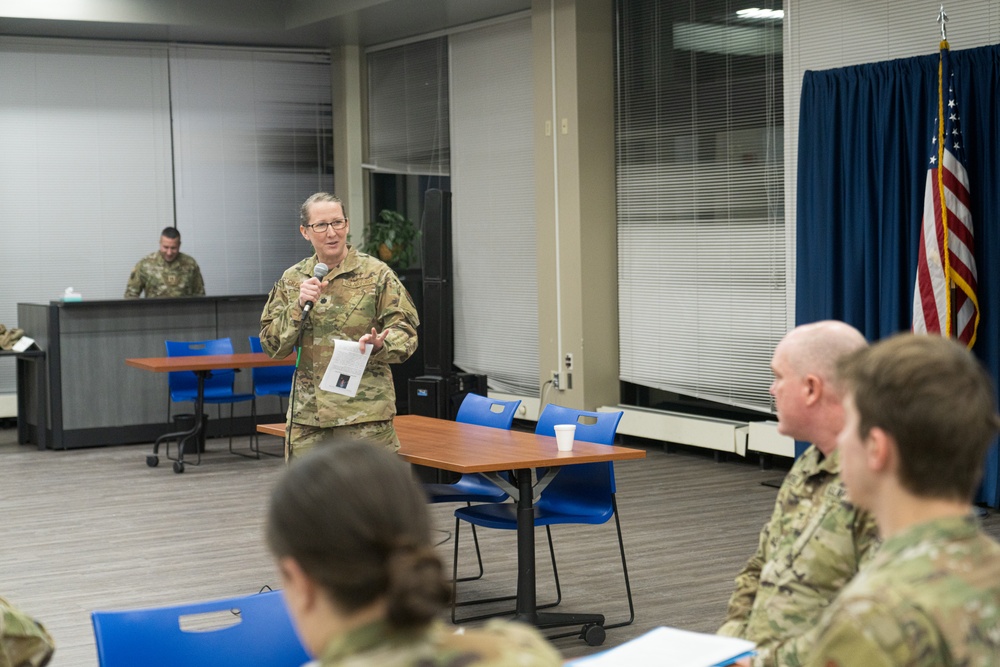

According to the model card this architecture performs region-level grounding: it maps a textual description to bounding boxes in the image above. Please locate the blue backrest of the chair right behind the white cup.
[535,403,623,521]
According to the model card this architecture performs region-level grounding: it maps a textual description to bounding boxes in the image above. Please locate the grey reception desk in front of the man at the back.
[17,294,284,449]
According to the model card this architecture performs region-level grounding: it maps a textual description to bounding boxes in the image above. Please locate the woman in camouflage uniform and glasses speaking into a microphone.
[260,192,419,459]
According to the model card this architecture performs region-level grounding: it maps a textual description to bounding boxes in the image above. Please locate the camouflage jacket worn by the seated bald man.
[718,446,879,667]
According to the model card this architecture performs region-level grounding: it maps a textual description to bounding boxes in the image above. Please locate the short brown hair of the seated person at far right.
[838,334,1000,501]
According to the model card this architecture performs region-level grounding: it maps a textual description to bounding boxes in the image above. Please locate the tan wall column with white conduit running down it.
[532,0,619,410]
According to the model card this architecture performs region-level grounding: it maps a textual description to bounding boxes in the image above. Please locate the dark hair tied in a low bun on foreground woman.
[267,442,450,628]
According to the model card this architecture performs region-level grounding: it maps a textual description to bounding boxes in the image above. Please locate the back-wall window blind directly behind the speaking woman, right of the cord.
[170,46,333,294]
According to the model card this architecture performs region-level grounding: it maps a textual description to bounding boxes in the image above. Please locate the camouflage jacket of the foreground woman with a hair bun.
[318,620,562,667]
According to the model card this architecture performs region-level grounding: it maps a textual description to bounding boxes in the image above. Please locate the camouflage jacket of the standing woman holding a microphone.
[260,248,420,428]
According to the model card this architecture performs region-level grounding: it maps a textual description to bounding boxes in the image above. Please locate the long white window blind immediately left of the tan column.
[449,18,538,396]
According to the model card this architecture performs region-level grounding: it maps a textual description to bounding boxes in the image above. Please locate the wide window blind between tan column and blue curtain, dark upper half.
[616,0,789,411]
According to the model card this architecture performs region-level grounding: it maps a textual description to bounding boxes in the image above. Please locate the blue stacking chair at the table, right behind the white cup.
[453,403,635,634]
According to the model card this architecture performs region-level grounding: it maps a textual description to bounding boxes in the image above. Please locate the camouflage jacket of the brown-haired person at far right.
[808,516,1000,667]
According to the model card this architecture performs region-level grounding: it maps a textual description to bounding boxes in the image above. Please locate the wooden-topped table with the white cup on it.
[257,415,646,640]
